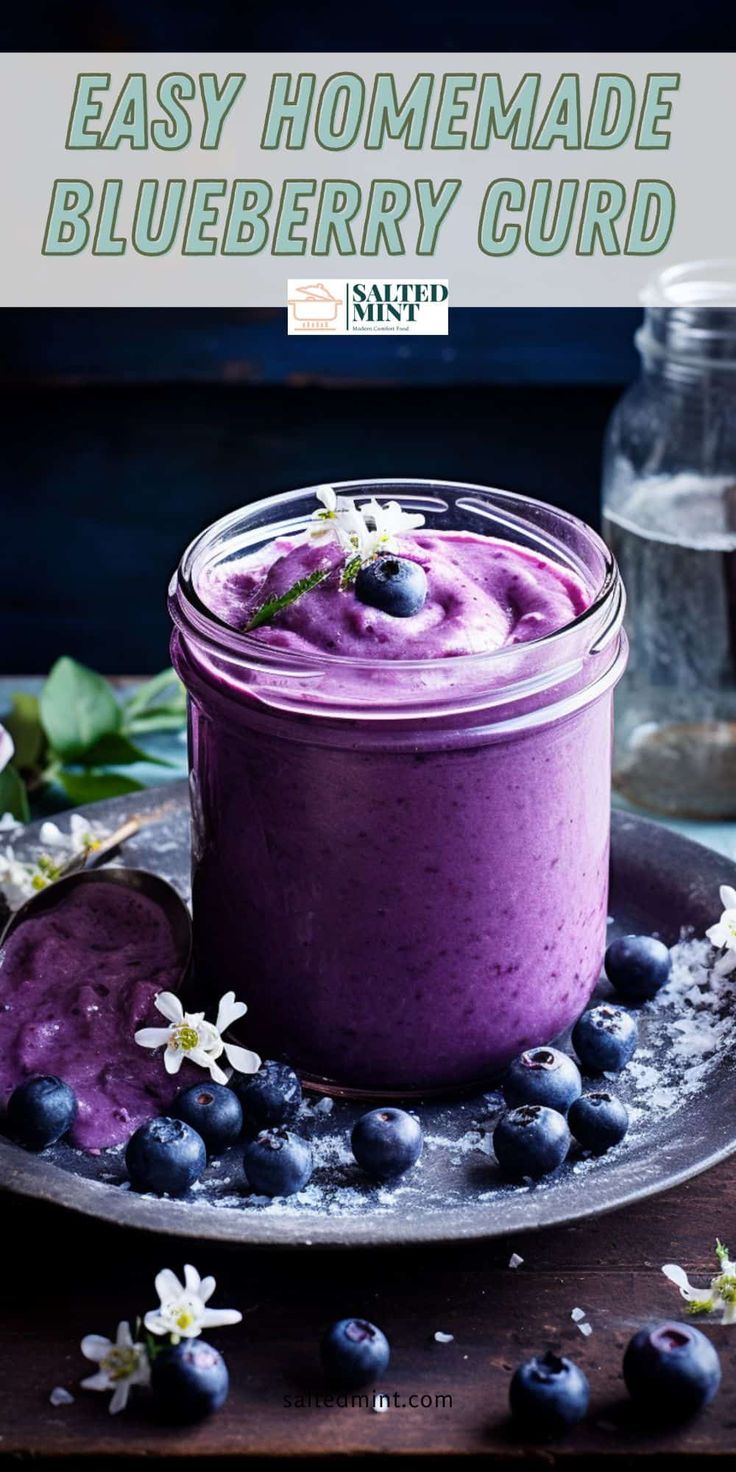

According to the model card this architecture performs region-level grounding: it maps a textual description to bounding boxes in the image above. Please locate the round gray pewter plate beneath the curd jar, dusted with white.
[0,783,736,1247]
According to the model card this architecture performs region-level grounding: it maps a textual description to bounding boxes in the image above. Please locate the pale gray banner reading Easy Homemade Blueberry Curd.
[0,53,736,310]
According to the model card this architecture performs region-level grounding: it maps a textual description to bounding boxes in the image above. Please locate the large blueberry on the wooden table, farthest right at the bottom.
[624,1323,721,1422]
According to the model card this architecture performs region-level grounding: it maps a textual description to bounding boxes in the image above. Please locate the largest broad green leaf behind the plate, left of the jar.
[41,655,121,761]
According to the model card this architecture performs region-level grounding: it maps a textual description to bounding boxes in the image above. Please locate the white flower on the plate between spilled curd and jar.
[135,992,261,1083]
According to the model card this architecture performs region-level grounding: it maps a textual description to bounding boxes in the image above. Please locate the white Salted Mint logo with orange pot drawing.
[287,278,449,337]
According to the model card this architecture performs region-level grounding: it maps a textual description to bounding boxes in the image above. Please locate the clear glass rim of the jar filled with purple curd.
[169,477,623,677]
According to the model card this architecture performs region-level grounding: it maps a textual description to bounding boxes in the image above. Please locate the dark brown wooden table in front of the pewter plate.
[0,1161,736,1465]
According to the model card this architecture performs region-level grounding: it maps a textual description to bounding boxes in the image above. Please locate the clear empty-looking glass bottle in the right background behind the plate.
[604,262,736,818]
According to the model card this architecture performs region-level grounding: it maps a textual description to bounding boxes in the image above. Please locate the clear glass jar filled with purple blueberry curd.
[169,481,626,1097]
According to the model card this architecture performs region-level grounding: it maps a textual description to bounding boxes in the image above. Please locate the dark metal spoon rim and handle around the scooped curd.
[0,818,191,988]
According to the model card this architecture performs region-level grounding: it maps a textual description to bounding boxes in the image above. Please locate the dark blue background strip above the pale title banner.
[3,0,735,52]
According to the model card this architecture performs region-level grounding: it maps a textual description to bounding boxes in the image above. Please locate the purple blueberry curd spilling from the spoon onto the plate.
[0,883,192,1150]
